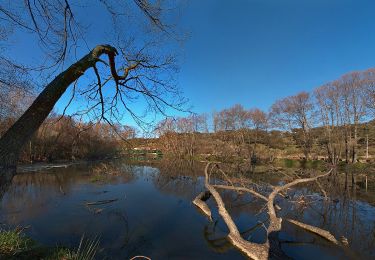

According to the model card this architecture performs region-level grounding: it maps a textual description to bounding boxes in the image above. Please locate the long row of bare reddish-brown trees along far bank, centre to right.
[157,69,375,164]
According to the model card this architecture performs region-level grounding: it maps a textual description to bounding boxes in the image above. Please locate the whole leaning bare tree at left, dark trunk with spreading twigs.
[0,0,185,185]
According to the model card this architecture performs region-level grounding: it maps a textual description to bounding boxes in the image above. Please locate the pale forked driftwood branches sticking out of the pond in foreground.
[193,163,346,259]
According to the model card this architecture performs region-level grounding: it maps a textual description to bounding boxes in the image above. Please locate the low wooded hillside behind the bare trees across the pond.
[130,120,375,162]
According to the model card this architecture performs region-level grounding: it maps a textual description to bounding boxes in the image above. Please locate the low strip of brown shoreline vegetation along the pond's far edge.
[18,154,375,179]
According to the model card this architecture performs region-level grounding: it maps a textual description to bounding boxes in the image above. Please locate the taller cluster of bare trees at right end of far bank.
[270,69,375,164]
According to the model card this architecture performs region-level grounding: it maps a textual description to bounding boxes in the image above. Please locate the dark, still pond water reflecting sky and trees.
[0,159,375,259]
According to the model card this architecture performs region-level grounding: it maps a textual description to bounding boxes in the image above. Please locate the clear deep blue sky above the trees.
[9,0,375,127]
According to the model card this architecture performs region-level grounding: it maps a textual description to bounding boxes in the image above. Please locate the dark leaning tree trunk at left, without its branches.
[0,45,117,185]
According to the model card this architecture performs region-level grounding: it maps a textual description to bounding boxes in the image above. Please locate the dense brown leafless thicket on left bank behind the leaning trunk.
[0,111,136,163]
